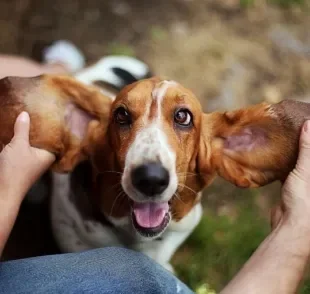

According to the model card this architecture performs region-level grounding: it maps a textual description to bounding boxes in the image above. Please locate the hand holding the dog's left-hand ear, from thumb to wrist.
[0,112,55,200]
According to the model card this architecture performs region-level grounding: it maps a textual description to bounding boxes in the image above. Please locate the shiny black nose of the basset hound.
[131,162,169,197]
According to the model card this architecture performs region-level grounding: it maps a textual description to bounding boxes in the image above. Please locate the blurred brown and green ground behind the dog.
[0,0,310,293]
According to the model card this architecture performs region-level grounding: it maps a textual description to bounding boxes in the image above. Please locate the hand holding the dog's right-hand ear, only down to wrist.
[271,121,310,228]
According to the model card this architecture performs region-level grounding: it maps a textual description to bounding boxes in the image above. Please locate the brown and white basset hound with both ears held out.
[0,76,310,271]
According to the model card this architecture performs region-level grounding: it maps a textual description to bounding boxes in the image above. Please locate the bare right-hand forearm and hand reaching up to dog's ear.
[221,121,310,294]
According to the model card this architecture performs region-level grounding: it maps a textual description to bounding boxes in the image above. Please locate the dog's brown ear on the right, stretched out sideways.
[199,100,310,187]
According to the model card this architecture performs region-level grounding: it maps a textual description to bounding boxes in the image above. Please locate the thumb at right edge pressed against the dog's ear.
[295,120,310,180]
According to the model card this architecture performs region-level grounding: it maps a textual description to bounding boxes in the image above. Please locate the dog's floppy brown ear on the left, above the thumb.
[0,75,111,172]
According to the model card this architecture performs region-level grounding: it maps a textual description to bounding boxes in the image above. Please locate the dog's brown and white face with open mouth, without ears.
[104,78,202,236]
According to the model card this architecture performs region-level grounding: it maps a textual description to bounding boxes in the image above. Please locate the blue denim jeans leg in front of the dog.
[0,247,193,294]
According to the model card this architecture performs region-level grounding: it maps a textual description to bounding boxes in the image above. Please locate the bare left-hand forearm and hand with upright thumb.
[0,112,55,255]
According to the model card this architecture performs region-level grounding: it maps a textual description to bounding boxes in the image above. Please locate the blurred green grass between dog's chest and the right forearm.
[173,195,310,294]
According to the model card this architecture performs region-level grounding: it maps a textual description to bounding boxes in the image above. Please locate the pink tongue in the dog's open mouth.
[133,202,169,228]
